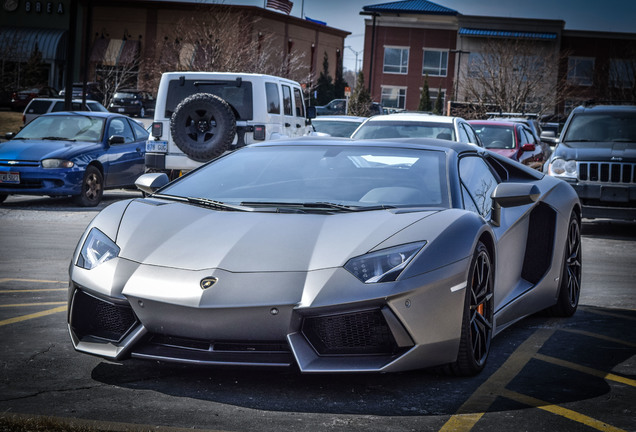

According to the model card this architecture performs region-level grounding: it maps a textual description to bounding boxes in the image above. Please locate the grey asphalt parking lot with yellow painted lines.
[0,191,636,431]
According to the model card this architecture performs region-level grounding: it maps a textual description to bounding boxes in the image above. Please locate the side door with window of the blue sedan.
[104,117,148,187]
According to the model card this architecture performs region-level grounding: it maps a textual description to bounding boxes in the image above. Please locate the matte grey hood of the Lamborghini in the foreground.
[116,199,435,272]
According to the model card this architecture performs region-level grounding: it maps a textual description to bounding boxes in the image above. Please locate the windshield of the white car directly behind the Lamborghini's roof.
[352,121,455,141]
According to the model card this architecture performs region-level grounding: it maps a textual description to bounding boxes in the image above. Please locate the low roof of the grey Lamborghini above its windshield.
[248,136,476,153]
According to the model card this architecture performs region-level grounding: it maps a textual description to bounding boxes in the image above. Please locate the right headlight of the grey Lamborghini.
[344,241,426,283]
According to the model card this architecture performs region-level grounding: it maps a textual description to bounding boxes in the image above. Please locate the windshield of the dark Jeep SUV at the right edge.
[562,112,636,147]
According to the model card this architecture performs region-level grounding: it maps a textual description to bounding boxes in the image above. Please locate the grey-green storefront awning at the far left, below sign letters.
[0,27,67,63]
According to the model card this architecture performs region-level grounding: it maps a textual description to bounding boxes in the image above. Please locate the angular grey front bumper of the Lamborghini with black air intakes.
[68,258,467,372]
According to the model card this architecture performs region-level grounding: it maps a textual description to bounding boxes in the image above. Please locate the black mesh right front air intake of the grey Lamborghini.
[302,310,397,354]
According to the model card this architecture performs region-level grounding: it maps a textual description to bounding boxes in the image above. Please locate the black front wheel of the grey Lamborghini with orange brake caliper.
[449,242,494,376]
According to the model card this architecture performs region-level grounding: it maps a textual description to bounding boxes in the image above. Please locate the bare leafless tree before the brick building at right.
[459,38,567,114]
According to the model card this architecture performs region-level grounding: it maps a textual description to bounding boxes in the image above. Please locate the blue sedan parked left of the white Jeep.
[0,112,148,207]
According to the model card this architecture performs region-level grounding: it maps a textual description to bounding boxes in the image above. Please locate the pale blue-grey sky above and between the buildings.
[223,0,636,70]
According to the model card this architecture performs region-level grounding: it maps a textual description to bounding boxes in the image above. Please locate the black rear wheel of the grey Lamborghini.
[548,213,582,317]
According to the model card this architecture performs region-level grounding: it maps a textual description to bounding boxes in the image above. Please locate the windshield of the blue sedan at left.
[13,114,104,142]
